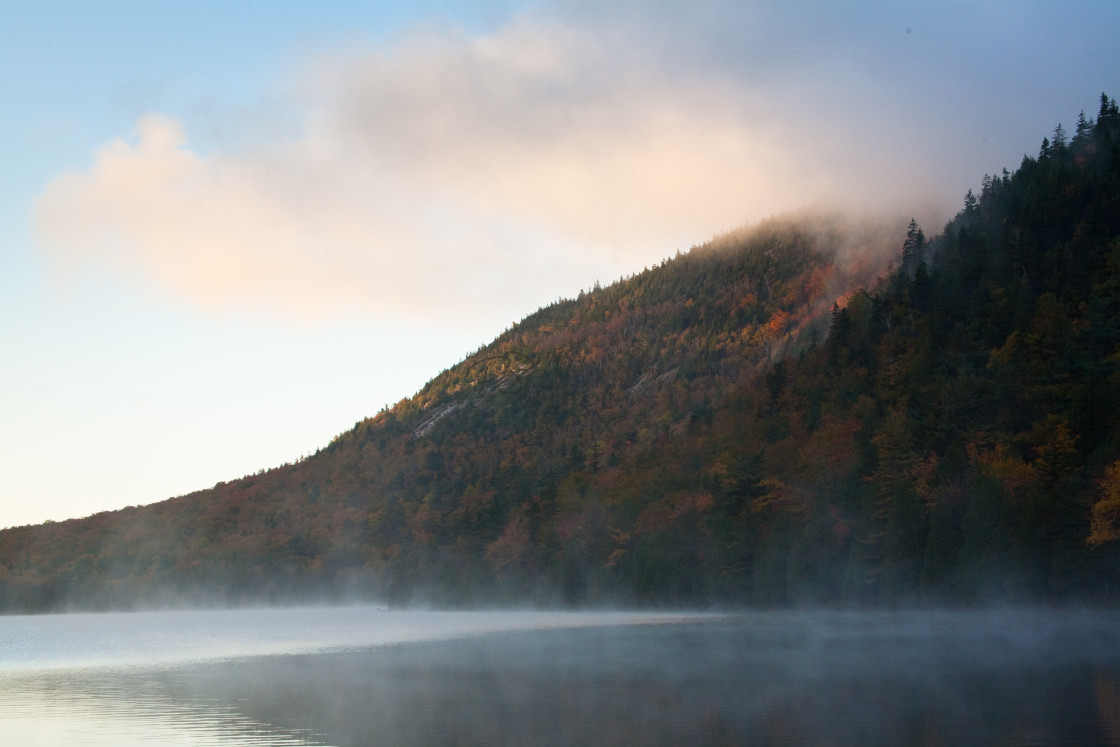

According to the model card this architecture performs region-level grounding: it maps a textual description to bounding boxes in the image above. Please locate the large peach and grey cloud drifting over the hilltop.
[35,3,1111,320]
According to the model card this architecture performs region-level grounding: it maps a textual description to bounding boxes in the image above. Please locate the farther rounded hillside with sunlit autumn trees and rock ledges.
[0,212,887,609]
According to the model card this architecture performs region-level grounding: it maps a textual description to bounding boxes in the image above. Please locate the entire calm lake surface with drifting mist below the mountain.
[0,607,1120,746]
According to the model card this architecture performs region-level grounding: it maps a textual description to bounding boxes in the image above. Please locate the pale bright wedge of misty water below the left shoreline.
[0,606,710,672]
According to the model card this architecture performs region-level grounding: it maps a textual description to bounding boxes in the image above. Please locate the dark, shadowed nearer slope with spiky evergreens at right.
[712,95,1120,603]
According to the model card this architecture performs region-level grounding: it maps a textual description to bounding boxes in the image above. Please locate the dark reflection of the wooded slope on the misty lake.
[8,614,1120,746]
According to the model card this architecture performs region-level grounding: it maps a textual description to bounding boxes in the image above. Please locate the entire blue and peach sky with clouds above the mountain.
[0,0,1120,526]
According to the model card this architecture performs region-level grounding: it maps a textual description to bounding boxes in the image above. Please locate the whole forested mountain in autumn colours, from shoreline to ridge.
[0,95,1120,611]
